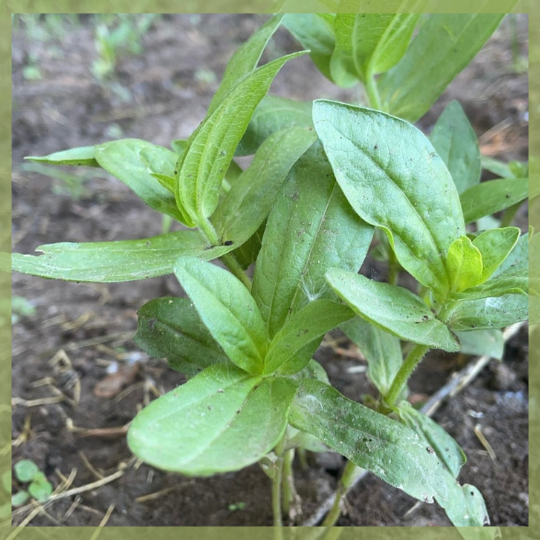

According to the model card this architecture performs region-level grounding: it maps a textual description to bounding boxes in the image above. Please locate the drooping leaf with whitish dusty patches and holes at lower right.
[289,380,487,526]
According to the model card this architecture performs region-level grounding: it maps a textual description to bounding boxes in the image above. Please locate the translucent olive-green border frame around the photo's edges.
[0,0,540,540]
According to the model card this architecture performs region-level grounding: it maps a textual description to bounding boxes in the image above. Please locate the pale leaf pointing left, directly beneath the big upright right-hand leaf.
[326,268,459,352]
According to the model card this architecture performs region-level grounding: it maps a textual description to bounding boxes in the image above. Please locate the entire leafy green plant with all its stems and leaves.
[13,14,528,526]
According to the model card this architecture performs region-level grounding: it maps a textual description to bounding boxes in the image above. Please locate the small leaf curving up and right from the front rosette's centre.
[263,299,354,375]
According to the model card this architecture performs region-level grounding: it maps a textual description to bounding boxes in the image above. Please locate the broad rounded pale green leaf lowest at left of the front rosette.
[128,364,296,476]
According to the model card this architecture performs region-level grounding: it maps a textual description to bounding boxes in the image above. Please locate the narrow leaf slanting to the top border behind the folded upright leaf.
[207,15,283,115]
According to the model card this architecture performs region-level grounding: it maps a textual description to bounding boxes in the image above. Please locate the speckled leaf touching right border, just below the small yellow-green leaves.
[444,294,529,332]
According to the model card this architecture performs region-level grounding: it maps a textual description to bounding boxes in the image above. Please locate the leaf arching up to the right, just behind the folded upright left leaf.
[212,128,317,246]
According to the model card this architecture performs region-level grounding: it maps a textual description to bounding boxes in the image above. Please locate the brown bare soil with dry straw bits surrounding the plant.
[13,15,528,526]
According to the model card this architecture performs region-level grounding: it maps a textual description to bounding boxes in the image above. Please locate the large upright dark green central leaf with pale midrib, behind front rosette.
[252,143,373,338]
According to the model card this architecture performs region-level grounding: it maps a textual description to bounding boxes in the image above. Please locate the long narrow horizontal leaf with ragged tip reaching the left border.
[12,231,234,283]
